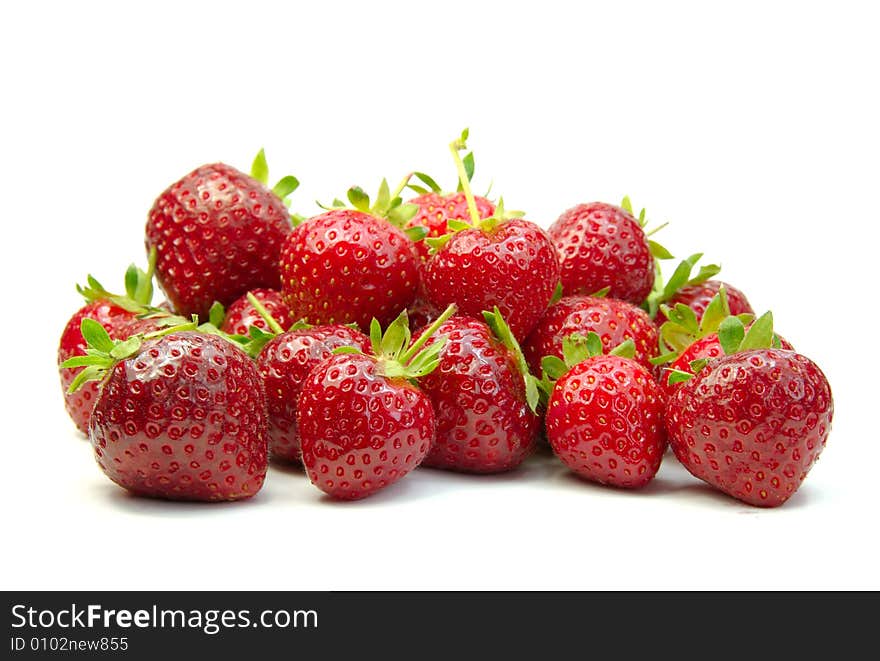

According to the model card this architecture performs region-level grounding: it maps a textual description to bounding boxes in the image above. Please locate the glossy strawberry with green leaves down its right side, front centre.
[416,309,539,473]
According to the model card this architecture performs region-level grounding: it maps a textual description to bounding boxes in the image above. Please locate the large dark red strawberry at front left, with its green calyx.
[66,319,267,500]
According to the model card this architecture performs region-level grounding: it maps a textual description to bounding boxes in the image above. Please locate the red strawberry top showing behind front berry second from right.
[523,295,658,374]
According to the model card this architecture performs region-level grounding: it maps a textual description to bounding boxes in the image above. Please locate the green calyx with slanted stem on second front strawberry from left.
[333,305,456,385]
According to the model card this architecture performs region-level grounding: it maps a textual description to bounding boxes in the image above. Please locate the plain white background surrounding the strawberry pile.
[0,0,880,589]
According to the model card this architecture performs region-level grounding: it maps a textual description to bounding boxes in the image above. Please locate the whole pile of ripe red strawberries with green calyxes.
[58,131,833,507]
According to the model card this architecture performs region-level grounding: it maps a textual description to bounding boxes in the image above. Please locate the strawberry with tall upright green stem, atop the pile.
[424,130,559,341]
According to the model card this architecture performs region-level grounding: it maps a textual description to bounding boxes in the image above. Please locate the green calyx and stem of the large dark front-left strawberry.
[60,316,198,393]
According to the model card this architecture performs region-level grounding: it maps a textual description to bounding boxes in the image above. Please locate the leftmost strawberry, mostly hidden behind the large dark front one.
[58,255,165,434]
